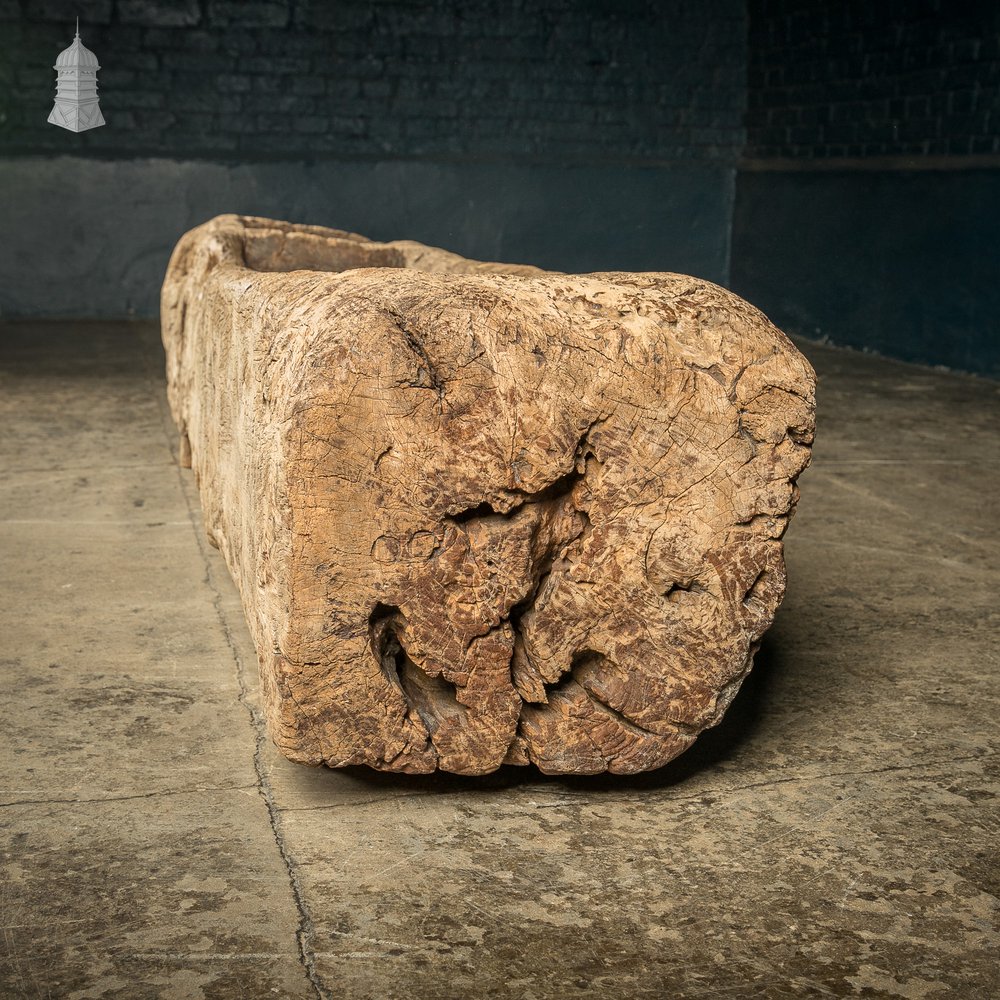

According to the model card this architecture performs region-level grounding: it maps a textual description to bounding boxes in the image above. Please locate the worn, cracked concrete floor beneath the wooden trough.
[0,323,1000,1000]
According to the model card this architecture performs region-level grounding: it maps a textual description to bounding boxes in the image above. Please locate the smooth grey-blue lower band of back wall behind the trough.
[0,157,735,316]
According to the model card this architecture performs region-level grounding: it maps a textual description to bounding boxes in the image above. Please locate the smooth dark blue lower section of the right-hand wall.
[732,170,1000,377]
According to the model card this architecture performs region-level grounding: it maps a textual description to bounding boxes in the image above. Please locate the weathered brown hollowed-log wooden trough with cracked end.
[162,216,814,774]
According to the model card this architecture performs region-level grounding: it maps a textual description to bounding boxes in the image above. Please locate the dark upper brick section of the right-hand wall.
[747,0,1000,159]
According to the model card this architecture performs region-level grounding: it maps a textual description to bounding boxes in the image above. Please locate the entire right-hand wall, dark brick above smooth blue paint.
[731,0,1000,376]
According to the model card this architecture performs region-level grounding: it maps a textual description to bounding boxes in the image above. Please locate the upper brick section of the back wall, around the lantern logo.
[0,0,746,163]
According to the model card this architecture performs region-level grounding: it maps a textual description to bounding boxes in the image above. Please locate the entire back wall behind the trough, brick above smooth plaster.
[0,0,746,316]
